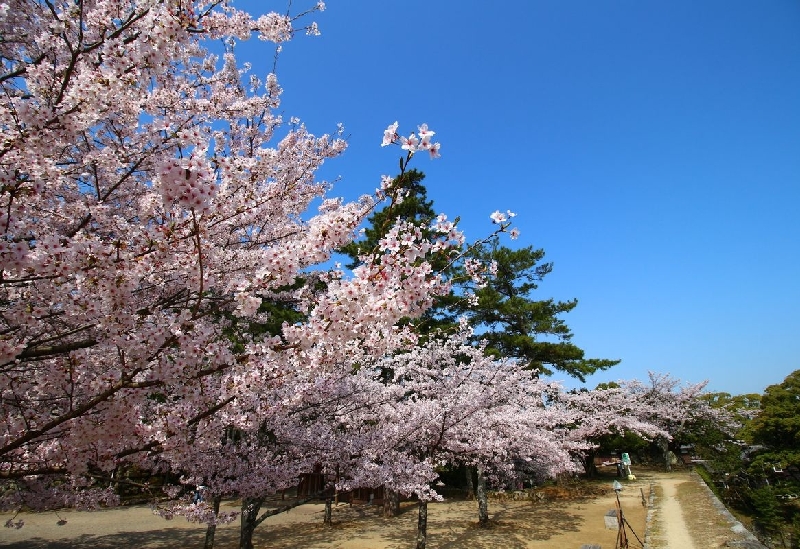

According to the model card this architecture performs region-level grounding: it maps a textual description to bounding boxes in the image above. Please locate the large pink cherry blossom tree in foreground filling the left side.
[0,0,460,520]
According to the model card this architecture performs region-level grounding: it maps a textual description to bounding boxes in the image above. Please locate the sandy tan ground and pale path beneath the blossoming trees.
[0,466,764,549]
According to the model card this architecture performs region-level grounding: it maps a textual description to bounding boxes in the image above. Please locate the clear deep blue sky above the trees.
[235,0,800,394]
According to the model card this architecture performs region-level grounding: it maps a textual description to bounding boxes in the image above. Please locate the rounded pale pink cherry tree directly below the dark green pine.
[318,331,575,548]
